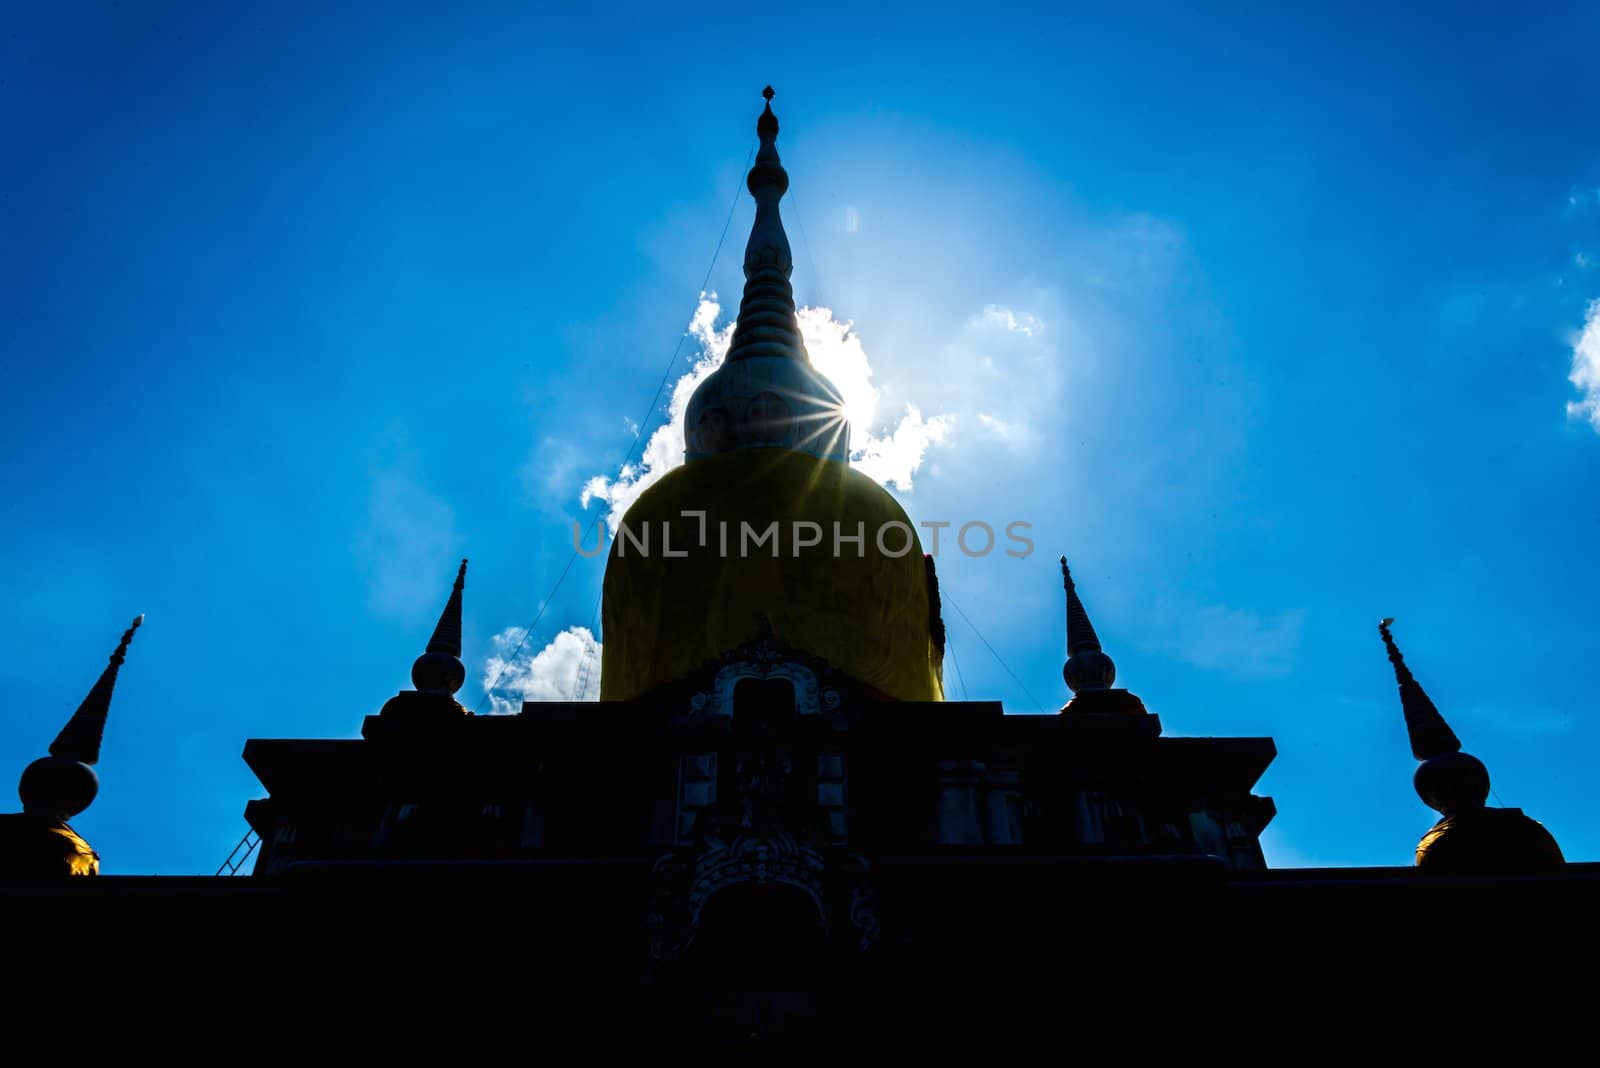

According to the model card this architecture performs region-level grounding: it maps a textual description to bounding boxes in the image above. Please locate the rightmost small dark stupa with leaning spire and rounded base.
[1378,617,1563,875]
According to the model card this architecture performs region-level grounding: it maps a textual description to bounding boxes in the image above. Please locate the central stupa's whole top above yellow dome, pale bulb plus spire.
[683,86,850,464]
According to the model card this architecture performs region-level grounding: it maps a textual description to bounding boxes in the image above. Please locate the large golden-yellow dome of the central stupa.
[600,448,944,700]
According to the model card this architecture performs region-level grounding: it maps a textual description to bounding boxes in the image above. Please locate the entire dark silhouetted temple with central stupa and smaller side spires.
[0,91,1600,1054]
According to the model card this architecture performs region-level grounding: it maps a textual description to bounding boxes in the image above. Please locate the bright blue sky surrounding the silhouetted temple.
[0,5,1600,873]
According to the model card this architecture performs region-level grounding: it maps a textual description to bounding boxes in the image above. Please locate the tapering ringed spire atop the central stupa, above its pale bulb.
[728,86,811,363]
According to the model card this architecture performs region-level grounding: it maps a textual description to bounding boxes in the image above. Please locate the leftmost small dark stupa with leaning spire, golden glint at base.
[0,616,144,879]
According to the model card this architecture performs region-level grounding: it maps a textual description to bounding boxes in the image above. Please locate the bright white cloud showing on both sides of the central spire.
[579,293,947,531]
